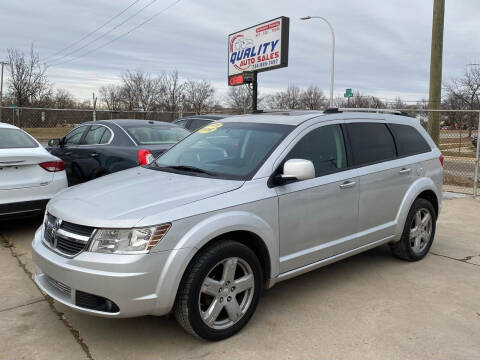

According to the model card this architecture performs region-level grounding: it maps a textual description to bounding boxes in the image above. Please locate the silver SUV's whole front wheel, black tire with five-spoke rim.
[174,239,263,341]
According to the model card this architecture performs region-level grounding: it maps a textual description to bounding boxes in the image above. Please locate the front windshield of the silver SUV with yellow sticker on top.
[155,122,294,180]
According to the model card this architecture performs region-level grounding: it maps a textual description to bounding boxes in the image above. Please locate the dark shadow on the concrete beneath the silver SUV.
[51,246,403,358]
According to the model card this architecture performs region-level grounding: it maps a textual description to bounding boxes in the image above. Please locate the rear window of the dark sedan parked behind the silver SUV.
[124,125,190,145]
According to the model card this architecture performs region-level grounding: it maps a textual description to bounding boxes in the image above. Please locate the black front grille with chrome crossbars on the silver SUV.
[44,214,94,256]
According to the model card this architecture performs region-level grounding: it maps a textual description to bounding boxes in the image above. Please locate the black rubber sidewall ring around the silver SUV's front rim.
[187,241,263,341]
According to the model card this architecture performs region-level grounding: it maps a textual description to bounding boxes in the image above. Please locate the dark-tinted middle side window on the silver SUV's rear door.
[346,123,396,166]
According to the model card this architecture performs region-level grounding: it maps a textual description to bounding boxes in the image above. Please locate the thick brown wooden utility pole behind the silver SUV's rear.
[428,0,445,145]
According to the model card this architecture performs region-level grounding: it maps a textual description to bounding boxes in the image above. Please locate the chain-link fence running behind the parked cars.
[0,107,480,194]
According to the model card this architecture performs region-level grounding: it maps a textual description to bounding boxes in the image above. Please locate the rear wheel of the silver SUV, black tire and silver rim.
[390,198,437,261]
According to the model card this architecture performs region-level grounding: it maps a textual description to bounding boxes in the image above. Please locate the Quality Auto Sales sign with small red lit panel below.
[228,16,289,86]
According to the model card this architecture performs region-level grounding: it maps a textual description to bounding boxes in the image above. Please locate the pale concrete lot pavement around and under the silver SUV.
[0,198,480,360]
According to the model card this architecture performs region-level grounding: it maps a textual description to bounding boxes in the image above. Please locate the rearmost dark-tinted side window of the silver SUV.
[390,124,432,156]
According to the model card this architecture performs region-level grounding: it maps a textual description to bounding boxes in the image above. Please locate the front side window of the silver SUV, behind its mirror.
[284,125,347,177]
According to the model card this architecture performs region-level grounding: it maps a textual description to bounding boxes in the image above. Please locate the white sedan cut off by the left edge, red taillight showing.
[0,123,68,219]
